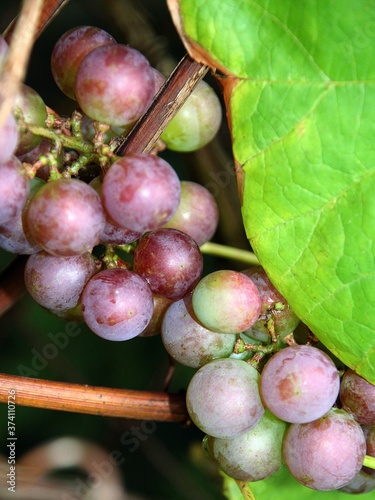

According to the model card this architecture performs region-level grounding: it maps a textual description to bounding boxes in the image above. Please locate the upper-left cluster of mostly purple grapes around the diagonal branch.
[0,26,221,341]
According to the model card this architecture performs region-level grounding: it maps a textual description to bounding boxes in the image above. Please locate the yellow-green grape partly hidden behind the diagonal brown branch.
[161,82,222,153]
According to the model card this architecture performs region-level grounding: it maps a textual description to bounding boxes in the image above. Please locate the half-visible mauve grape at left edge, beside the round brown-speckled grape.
[0,156,29,225]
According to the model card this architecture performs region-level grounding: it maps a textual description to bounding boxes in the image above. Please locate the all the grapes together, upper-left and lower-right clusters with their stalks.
[0,26,375,492]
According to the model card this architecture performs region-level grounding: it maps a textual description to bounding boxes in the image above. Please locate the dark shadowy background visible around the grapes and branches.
[0,0,253,500]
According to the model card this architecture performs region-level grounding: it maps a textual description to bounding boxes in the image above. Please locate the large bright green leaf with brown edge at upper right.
[168,0,375,383]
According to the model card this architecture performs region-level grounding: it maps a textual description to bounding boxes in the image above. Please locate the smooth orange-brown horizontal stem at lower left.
[0,374,189,424]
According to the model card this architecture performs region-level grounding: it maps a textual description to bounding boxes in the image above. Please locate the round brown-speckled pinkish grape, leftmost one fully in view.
[27,179,105,256]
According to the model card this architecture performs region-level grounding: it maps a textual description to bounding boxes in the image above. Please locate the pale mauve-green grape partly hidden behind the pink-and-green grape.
[161,295,236,368]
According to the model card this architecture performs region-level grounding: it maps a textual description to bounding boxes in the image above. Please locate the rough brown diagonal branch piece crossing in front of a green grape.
[115,54,208,156]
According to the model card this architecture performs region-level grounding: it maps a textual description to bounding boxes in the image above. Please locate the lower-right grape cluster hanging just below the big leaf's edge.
[161,266,375,493]
